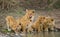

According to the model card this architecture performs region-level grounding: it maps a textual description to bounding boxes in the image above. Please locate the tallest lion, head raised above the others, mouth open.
[17,9,35,33]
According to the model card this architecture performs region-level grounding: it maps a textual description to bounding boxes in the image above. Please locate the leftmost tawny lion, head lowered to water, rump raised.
[6,16,21,34]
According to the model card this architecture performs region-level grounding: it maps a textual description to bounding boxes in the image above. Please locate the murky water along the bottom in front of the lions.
[0,32,60,37]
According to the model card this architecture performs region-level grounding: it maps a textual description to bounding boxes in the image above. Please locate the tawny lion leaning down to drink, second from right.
[28,16,45,32]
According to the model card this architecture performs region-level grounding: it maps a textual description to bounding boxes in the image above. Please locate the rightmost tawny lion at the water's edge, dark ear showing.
[43,17,55,31]
